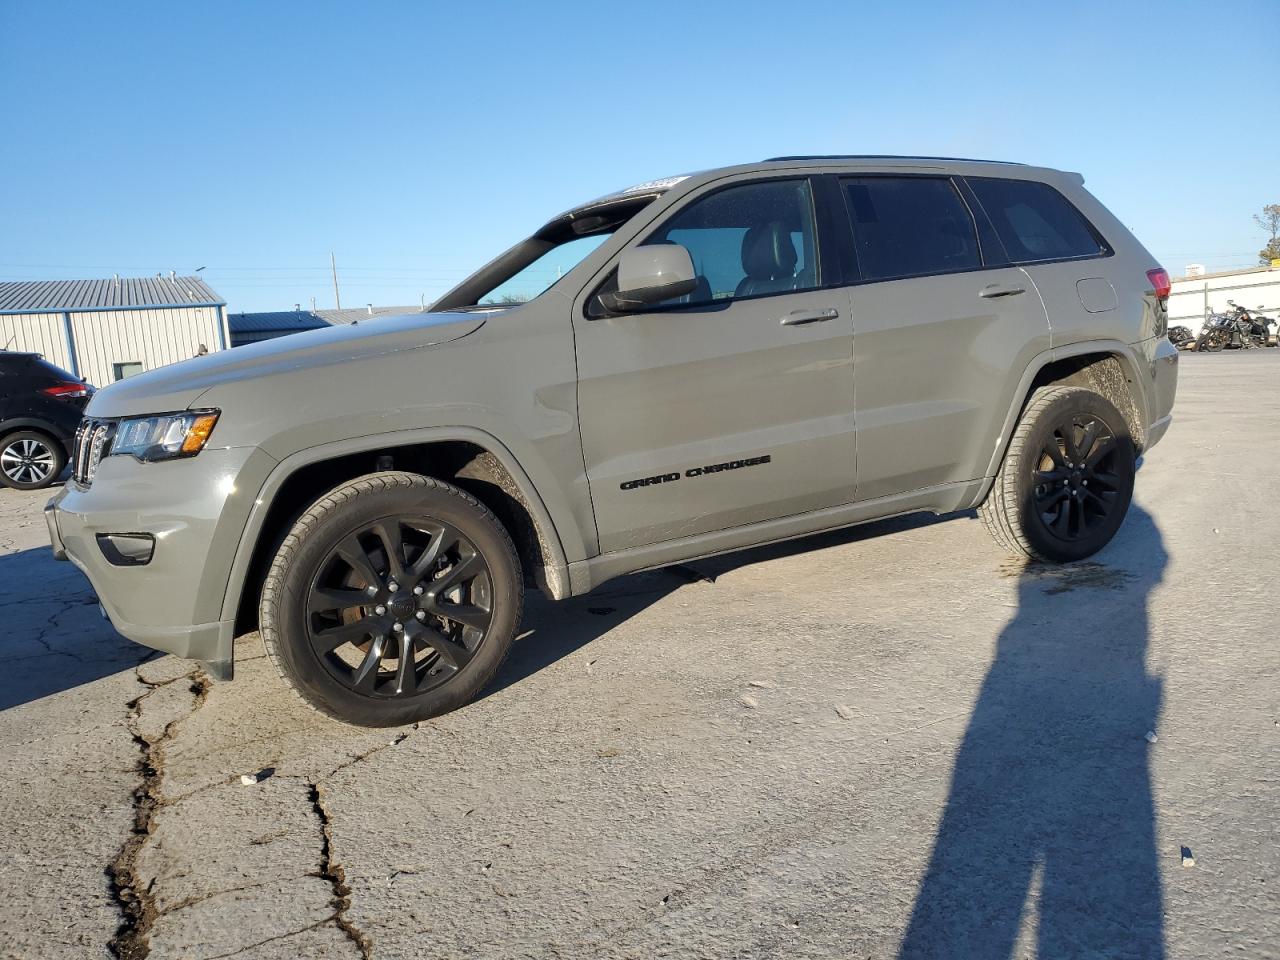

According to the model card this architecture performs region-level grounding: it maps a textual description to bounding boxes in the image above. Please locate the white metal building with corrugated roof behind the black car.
[0,274,230,387]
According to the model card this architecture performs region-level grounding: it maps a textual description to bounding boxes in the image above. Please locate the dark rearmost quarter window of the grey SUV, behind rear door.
[968,177,1107,264]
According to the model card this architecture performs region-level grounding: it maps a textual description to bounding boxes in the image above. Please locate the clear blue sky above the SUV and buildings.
[0,0,1280,311]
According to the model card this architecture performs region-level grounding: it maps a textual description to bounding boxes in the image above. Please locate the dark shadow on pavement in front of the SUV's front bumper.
[0,547,148,710]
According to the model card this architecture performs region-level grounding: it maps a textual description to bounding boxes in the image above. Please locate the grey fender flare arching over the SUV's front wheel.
[221,426,570,621]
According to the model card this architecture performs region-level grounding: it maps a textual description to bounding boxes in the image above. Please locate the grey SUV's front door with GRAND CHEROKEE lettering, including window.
[575,177,854,553]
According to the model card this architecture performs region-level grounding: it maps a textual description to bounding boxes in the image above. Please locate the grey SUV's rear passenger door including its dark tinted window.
[841,174,1050,500]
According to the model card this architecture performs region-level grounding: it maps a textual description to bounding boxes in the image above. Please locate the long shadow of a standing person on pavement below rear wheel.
[900,504,1167,960]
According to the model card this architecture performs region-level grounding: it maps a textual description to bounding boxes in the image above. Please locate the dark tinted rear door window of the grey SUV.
[841,177,982,280]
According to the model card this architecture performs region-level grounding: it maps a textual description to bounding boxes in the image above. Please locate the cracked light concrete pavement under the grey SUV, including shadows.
[0,351,1280,959]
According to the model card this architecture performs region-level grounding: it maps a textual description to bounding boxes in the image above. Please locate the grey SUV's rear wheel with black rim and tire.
[978,387,1135,563]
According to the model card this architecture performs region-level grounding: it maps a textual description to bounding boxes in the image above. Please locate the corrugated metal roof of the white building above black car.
[0,276,225,314]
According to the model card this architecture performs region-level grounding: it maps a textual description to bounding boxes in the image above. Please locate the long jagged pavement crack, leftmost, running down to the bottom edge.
[106,664,210,960]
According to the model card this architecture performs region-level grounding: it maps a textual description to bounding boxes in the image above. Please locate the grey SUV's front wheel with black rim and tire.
[260,472,525,727]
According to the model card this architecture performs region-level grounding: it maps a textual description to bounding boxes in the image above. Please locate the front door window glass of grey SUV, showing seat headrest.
[645,179,822,306]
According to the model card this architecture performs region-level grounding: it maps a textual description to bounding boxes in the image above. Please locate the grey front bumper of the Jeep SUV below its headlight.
[45,448,275,672]
